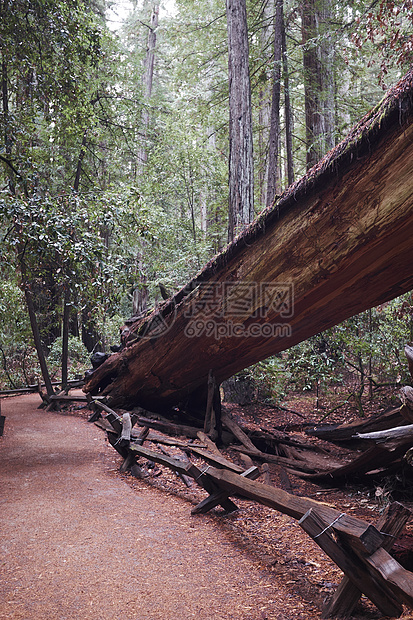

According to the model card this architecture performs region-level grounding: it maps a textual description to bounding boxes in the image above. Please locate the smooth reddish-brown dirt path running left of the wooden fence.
[0,395,304,620]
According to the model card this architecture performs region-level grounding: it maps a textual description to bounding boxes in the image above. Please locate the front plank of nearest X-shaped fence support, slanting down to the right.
[299,508,403,618]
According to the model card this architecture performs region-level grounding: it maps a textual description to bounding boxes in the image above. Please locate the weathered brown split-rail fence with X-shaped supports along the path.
[88,397,413,618]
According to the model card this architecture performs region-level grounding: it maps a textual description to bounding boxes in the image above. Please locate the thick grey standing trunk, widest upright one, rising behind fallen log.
[226,0,254,241]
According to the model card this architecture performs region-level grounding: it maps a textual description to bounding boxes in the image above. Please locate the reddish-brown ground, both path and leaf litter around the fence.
[0,395,413,620]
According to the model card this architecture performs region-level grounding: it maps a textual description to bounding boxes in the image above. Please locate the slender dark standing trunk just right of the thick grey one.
[266,0,283,206]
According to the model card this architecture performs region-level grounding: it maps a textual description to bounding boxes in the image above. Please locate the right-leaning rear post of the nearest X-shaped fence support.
[322,502,411,618]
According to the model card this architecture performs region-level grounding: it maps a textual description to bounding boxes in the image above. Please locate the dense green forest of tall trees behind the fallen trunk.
[0,0,413,413]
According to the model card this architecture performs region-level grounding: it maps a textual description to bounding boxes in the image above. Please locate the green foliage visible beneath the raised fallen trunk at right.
[245,293,413,410]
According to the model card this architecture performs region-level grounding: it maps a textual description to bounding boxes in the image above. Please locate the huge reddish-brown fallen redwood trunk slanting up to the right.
[85,71,413,411]
